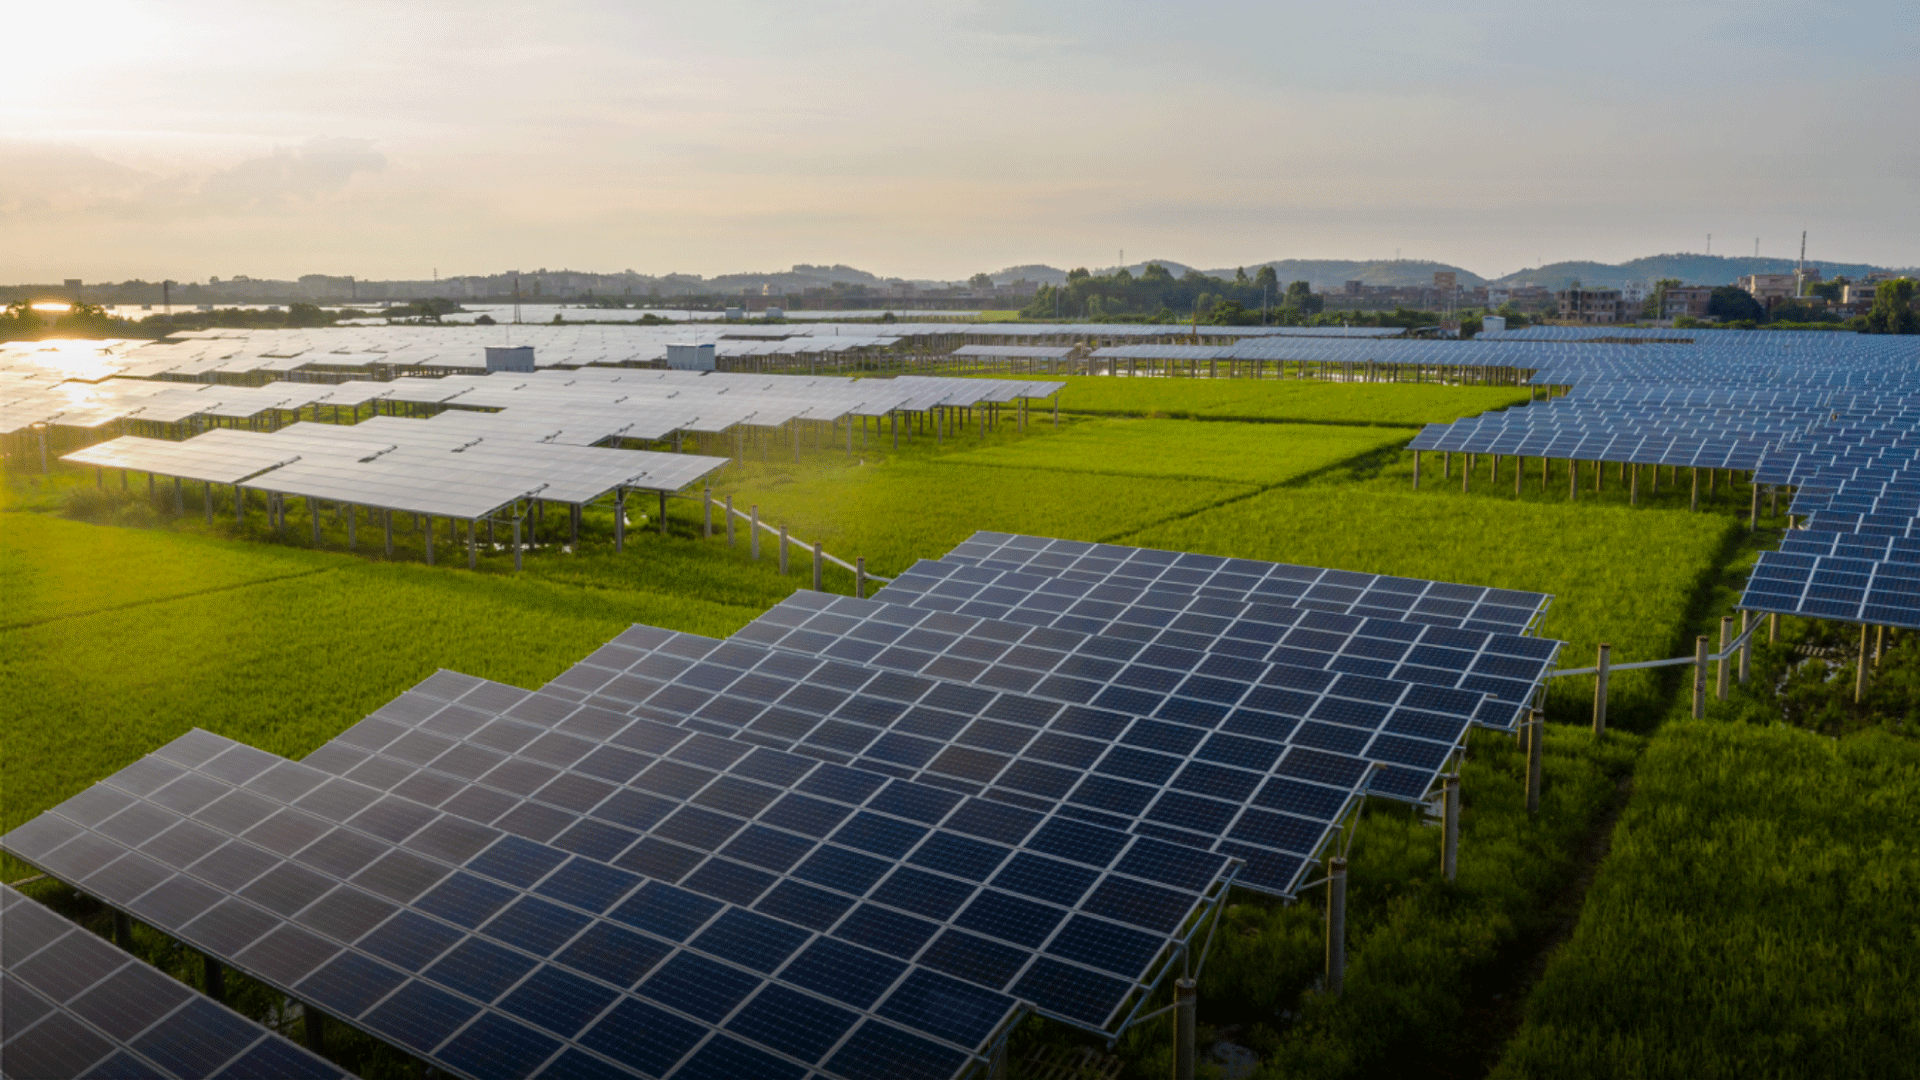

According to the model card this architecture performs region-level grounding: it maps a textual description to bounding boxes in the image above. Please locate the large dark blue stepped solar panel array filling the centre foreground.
[0,534,1559,1080]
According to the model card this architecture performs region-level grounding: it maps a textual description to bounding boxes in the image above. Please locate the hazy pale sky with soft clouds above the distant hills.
[0,0,1920,282]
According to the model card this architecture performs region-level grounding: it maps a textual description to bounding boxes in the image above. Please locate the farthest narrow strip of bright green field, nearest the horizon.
[1046,375,1526,427]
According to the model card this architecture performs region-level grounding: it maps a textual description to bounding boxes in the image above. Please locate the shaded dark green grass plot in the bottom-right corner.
[1494,719,1920,1080]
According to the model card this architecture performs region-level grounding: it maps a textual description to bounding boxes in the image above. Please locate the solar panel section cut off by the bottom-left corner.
[0,886,346,1080]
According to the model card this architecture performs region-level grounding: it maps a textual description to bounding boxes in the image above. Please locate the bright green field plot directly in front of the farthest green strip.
[937,419,1415,486]
